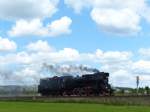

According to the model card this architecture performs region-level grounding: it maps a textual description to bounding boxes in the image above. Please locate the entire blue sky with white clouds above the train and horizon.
[0,0,150,87]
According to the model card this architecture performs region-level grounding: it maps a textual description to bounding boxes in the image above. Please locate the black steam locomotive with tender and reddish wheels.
[38,72,112,96]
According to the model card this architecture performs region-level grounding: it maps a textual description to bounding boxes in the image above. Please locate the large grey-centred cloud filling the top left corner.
[0,0,59,20]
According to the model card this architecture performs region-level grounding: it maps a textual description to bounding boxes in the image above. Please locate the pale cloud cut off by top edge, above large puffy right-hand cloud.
[65,0,147,12]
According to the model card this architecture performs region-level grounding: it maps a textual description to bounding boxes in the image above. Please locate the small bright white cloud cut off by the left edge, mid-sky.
[0,37,17,52]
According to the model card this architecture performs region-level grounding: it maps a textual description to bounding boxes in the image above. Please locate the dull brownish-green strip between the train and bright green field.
[0,95,150,106]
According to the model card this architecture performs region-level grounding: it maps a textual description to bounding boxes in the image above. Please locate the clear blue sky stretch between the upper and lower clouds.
[7,1,150,52]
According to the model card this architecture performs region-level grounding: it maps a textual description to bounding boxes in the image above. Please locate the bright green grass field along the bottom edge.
[0,102,150,112]
